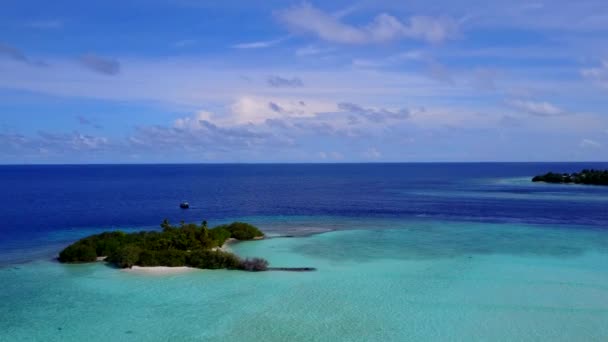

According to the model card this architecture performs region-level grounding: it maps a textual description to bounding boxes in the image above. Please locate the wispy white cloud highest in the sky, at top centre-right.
[277,3,458,44]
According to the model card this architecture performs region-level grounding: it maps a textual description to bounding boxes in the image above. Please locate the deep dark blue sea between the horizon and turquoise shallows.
[0,163,608,264]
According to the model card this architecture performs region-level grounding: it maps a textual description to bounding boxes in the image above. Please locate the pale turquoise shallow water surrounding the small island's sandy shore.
[0,217,608,341]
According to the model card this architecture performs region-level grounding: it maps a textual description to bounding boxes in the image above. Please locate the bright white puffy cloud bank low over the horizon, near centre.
[166,96,410,146]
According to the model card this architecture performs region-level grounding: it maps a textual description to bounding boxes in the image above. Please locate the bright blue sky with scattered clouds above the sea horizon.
[0,0,608,164]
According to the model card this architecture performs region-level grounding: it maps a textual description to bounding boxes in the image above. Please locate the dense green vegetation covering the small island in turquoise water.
[59,219,268,271]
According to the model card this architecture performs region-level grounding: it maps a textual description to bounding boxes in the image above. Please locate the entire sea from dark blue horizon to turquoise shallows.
[0,163,608,341]
